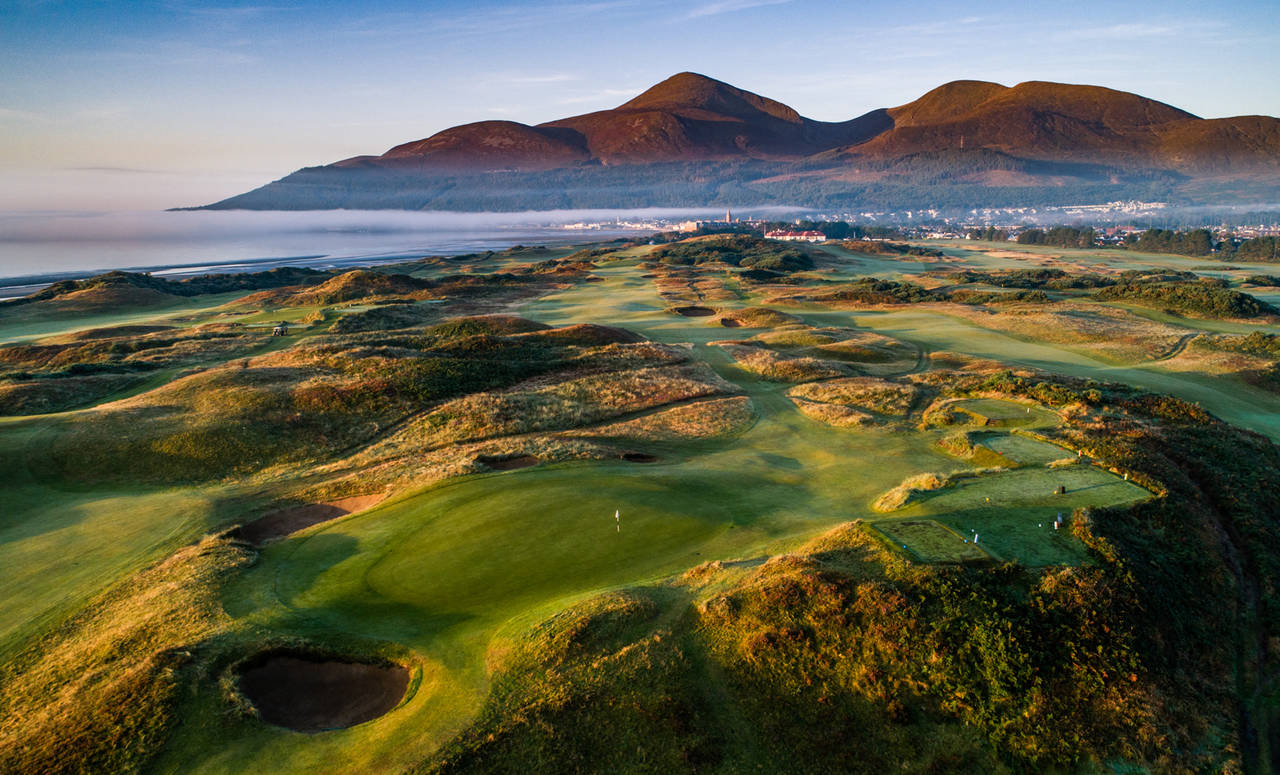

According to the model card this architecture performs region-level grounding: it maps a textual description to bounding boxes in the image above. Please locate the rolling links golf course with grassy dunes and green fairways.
[0,234,1280,774]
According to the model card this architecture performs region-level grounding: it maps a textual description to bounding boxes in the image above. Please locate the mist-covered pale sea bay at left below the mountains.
[0,209,773,286]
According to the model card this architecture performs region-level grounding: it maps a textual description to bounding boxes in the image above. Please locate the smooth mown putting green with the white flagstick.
[275,466,762,635]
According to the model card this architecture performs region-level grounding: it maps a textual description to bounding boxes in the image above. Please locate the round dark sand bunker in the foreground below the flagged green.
[239,655,408,731]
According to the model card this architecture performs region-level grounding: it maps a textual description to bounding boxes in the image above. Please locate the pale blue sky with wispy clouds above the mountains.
[0,0,1280,210]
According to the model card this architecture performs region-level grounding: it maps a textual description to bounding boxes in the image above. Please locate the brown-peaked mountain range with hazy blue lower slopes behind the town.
[197,73,1280,210]
